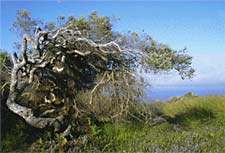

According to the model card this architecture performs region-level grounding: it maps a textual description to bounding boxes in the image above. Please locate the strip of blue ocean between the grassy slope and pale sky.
[144,83,225,102]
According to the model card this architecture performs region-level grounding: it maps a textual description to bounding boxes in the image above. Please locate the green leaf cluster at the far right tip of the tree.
[142,41,195,79]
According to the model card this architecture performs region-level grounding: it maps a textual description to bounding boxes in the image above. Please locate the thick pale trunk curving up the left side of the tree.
[7,28,63,128]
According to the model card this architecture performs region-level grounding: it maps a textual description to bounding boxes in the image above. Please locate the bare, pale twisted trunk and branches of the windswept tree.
[7,24,132,133]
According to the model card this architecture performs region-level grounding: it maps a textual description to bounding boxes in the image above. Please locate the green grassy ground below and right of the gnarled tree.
[1,94,225,152]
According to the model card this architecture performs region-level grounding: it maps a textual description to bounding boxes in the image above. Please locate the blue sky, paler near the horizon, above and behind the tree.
[0,0,225,85]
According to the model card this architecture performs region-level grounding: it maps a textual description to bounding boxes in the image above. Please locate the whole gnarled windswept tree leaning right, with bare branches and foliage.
[7,11,194,133]
